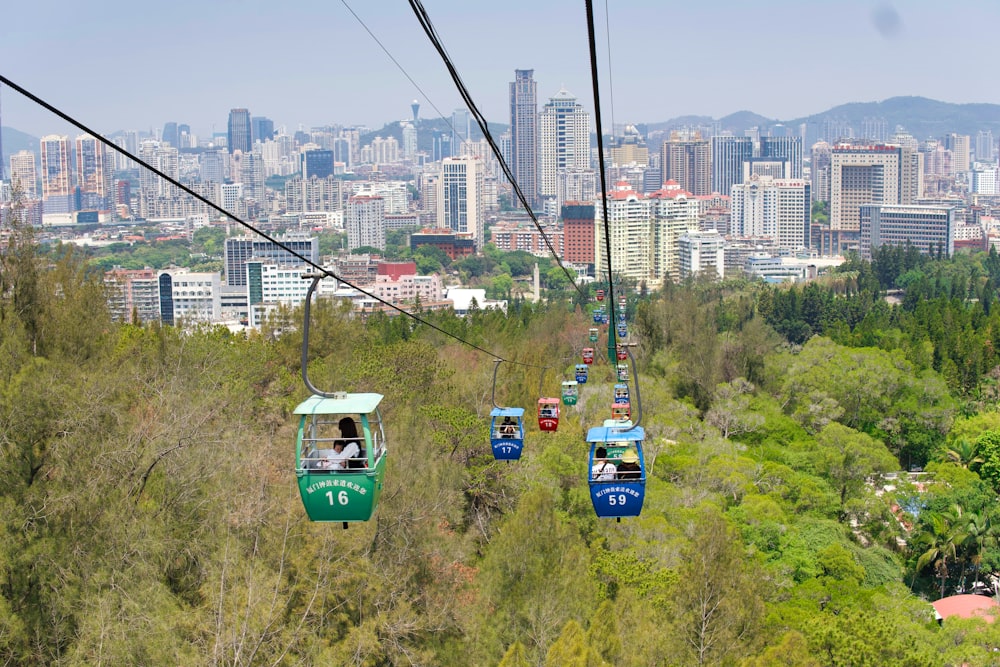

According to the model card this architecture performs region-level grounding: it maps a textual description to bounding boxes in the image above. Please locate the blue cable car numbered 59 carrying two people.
[587,422,646,519]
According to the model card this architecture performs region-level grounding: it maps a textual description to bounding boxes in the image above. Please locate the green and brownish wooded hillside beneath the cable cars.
[0,218,1000,667]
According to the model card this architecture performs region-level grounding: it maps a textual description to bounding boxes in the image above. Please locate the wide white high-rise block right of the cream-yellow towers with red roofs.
[730,175,812,250]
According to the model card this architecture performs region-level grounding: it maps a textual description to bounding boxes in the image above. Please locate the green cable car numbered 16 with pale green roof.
[295,392,385,527]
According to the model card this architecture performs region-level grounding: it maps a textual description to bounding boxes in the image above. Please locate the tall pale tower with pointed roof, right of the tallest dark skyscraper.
[538,88,590,204]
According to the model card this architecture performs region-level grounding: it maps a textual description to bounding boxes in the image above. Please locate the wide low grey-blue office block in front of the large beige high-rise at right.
[859,204,955,260]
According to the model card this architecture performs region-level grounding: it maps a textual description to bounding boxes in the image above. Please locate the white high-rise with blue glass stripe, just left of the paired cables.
[437,157,485,249]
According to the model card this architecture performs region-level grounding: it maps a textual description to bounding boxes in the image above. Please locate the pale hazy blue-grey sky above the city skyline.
[0,0,1000,136]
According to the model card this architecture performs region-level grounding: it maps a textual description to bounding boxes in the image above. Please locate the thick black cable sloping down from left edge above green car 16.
[0,75,548,376]
